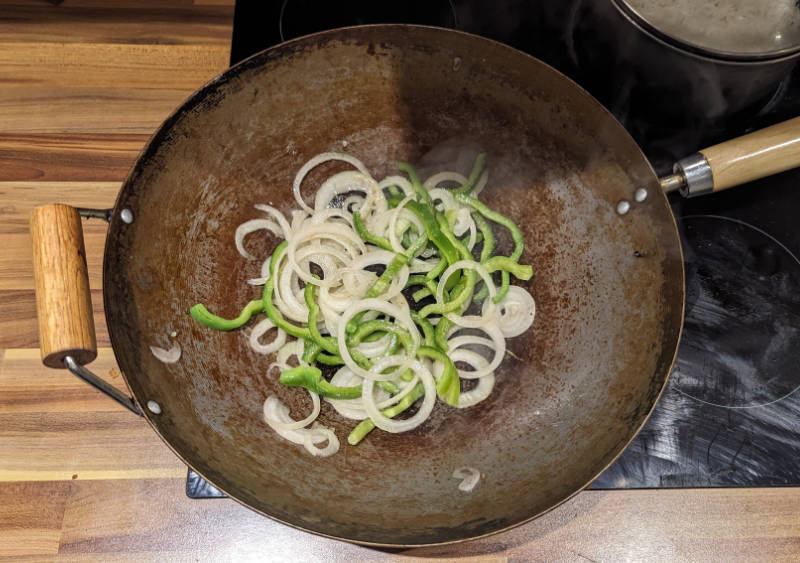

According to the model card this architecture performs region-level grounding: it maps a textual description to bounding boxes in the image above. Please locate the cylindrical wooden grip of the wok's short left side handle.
[31,203,97,368]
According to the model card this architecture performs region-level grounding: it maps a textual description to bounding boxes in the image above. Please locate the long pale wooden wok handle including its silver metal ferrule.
[672,117,800,197]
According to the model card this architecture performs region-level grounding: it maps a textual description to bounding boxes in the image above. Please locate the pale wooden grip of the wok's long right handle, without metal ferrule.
[700,117,800,192]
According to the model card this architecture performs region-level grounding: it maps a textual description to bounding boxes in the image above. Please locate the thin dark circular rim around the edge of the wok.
[102,24,686,549]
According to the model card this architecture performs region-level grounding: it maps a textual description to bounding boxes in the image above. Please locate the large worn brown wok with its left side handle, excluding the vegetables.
[32,25,800,546]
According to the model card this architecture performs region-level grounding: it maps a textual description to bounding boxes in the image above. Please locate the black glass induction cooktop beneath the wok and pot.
[187,0,800,497]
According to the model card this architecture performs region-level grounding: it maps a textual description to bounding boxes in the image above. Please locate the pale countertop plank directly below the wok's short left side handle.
[0,349,186,483]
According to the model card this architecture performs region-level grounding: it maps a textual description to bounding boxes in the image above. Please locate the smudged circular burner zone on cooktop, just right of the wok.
[672,214,800,409]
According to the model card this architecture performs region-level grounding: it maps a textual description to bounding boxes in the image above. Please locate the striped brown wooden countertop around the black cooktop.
[0,0,800,561]
